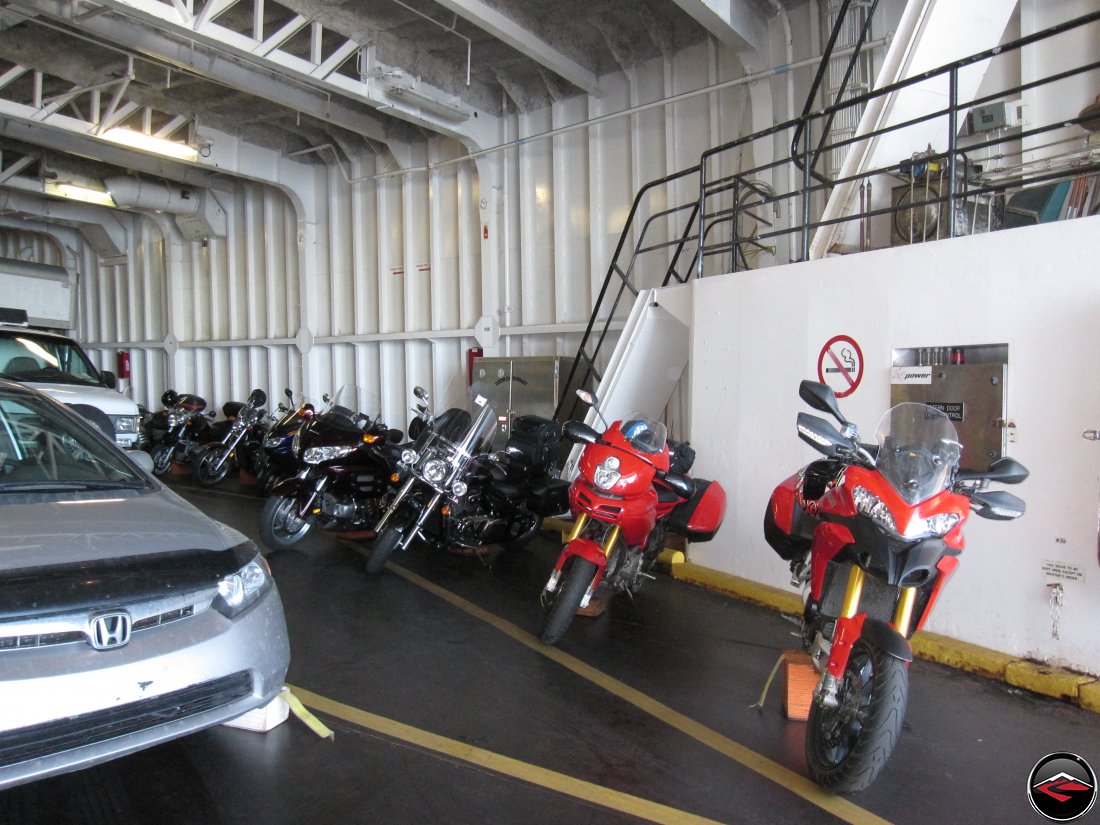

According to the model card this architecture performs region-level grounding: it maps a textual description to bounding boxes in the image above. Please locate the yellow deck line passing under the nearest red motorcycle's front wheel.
[382,562,889,825]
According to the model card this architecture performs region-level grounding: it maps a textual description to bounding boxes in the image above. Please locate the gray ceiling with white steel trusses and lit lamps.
[0,0,800,205]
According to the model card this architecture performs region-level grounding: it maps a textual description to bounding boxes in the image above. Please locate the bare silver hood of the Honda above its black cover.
[0,488,248,571]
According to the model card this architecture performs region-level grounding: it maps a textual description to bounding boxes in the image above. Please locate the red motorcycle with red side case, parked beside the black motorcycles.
[539,393,726,645]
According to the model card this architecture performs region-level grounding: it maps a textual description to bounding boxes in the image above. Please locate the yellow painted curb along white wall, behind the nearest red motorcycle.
[672,561,1100,713]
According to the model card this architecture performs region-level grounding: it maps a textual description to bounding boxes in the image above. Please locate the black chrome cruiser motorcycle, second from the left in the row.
[191,389,268,487]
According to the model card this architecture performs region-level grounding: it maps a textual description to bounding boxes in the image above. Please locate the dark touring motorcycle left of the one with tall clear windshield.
[260,391,402,550]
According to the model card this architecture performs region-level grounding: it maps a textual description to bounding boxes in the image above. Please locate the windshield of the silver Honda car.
[0,387,147,495]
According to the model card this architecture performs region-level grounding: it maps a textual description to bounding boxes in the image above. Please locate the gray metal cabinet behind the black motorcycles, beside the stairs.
[472,355,574,448]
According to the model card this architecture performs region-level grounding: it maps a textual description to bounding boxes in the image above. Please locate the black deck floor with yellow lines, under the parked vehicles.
[0,481,1100,825]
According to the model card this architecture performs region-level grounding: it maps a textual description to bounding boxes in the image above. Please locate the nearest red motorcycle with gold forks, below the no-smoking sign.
[763,381,1027,793]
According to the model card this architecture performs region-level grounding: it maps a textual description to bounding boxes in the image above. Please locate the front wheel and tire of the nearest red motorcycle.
[806,638,909,793]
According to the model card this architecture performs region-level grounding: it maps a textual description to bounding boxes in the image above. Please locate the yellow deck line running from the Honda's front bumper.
[288,685,721,825]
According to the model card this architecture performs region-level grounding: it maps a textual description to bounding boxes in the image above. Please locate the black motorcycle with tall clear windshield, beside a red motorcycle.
[366,385,569,573]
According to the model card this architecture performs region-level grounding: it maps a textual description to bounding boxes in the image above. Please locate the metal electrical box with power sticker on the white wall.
[890,347,1009,471]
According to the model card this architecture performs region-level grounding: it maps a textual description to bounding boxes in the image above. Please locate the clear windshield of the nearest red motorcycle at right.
[876,402,963,504]
